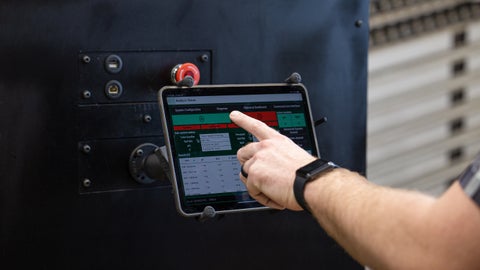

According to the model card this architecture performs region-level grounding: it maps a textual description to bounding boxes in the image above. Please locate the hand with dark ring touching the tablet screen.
[230,111,315,210]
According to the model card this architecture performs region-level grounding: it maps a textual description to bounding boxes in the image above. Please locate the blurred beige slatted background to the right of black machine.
[367,0,480,195]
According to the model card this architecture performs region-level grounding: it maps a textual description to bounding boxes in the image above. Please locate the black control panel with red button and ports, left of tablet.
[76,50,212,194]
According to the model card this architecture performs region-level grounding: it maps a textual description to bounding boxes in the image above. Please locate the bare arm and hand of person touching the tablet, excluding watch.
[230,111,480,270]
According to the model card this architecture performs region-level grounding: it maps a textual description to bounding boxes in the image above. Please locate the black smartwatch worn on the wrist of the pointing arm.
[293,159,338,214]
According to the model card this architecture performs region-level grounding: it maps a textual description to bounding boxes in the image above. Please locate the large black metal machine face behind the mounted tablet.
[0,0,368,269]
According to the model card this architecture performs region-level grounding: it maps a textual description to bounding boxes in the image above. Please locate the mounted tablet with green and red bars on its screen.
[159,84,318,216]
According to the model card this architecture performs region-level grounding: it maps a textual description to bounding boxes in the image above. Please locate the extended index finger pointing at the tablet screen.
[230,111,278,141]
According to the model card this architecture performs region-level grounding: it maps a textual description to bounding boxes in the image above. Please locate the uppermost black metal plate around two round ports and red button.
[77,50,211,105]
